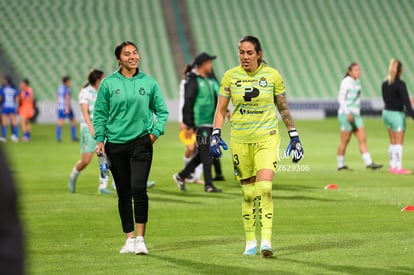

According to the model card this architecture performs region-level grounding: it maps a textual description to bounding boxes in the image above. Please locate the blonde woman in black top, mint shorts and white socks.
[382,59,414,174]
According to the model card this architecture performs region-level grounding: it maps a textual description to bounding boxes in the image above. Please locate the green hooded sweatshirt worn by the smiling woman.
[93,71,168,143]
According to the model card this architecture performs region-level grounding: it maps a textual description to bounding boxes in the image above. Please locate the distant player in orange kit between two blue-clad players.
[19,79,35,141]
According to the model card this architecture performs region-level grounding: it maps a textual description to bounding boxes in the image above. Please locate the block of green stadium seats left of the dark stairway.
[0,0,178,100]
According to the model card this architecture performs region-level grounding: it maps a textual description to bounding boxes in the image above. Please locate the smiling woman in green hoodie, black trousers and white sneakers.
[93,41,168,254]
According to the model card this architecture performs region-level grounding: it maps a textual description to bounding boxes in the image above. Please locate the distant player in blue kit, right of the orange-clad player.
[56,76,78,142]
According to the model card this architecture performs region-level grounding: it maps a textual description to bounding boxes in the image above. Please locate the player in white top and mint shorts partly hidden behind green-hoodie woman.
[69,69,113,194]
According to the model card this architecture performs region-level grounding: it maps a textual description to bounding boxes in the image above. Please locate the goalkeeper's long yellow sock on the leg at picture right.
[256,181,273,242]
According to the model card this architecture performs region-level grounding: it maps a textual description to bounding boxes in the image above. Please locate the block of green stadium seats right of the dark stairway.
[186,0,414,100]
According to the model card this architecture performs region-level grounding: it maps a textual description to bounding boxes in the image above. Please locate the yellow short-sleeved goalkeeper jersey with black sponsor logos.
[219,64,285,143]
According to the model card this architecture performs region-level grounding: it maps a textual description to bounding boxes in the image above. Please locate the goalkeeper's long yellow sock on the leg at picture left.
[242,183,256,241]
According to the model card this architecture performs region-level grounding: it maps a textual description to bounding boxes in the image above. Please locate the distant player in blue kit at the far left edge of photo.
[0,76,19,142]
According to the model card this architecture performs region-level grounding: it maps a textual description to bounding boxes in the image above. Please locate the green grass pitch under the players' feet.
[5,118,414,274]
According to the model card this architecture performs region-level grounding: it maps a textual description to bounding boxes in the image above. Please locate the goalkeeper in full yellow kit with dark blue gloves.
[210,36,303,258]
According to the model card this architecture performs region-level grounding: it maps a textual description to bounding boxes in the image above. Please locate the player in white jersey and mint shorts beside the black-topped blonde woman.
[336,63,382,171]
